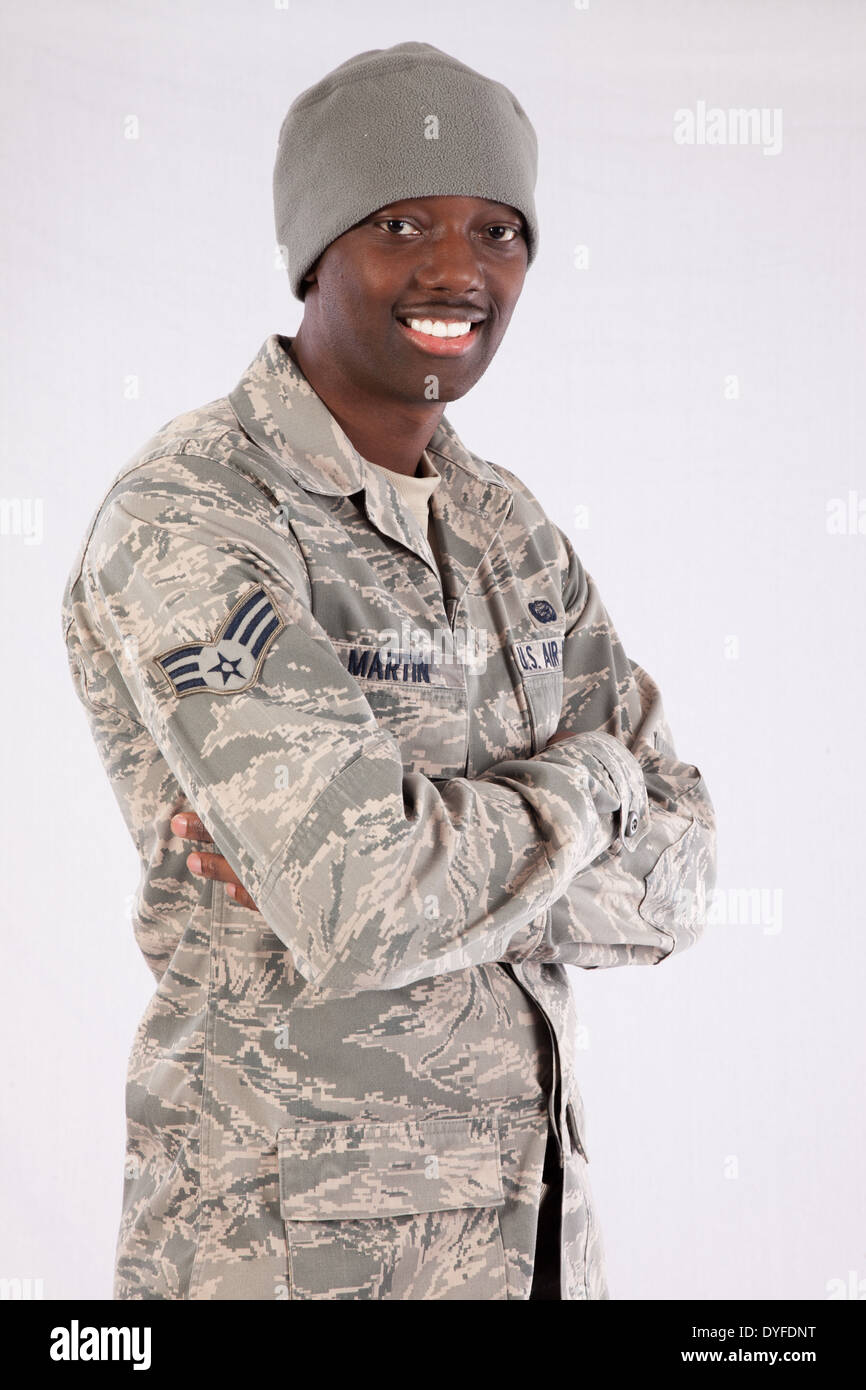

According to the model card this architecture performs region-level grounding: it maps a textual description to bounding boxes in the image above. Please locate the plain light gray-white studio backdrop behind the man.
[0,0,866,1300]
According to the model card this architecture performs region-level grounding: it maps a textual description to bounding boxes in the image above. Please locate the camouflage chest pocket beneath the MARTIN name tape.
[332,639,468,778]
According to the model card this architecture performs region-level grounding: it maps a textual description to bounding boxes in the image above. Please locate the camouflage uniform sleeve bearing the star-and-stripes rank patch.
[82,493,647,992]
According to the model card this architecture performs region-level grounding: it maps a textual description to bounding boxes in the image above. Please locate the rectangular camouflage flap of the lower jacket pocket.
[277,1118,505,1220]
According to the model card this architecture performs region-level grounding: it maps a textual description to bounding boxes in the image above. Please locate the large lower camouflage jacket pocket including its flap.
[277,1118,507,1300]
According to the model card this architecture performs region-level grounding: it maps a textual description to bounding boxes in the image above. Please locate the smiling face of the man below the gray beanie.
[297,197,528,403]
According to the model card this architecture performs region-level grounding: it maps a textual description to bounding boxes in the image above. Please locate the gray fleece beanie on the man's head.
[274,43,538,300]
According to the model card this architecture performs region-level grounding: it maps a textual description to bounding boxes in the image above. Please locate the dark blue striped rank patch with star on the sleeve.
[153,584,285,696]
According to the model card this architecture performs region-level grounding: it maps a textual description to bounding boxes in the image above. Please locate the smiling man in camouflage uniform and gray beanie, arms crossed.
[64,43,716,1300]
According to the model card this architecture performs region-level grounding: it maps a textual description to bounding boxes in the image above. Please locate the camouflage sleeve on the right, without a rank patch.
[537,528,716,969]
